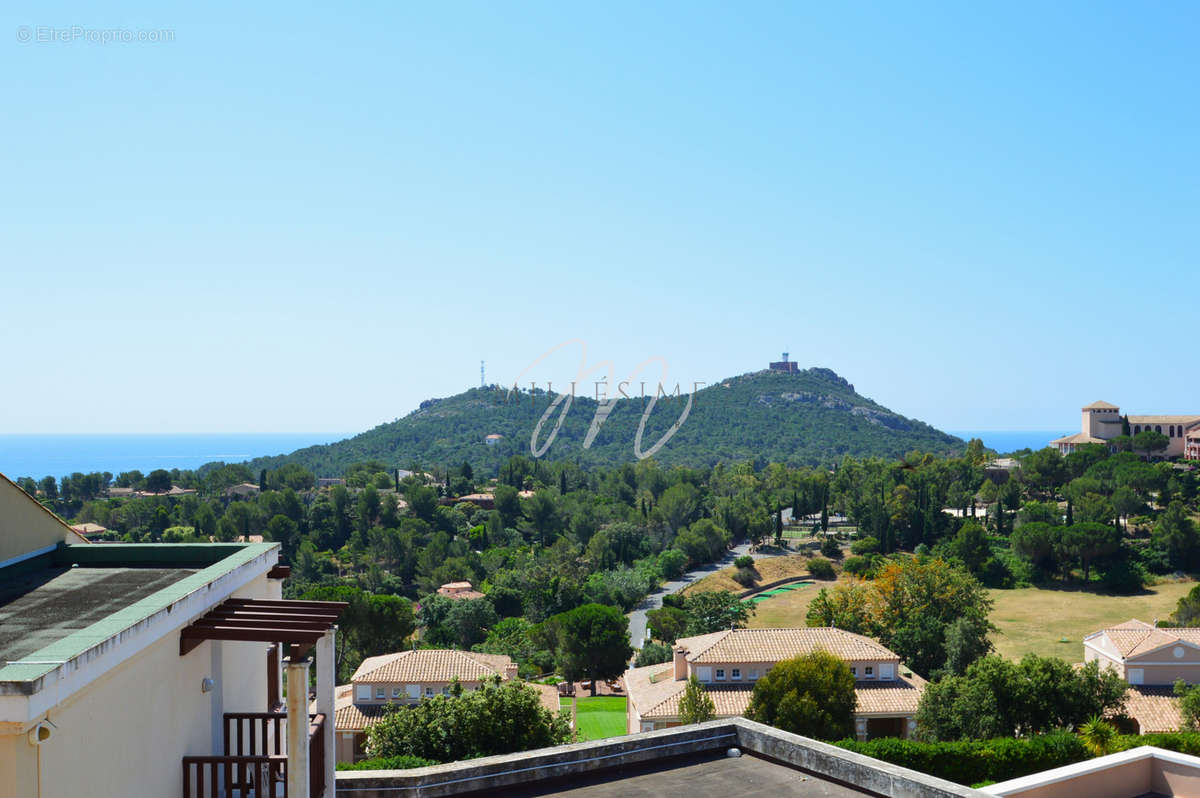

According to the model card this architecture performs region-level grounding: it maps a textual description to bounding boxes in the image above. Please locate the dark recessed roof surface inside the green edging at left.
[0,565,198,666]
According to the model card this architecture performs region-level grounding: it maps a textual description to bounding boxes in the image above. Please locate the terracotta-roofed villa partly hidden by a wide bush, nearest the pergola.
[335,648,559,762]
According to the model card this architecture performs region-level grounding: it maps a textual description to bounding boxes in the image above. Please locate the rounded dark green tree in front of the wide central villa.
[746,650,858,740]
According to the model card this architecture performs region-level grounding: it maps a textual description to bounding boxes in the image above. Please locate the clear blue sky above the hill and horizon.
[0,1,1200,432]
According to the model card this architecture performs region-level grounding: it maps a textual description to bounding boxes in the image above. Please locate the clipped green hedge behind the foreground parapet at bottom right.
[836,732,1200,785]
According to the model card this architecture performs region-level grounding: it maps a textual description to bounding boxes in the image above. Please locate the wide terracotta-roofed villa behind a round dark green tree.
[625,628,925,739]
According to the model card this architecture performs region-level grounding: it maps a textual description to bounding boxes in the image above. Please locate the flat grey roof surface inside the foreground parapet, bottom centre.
[474,751,874,798]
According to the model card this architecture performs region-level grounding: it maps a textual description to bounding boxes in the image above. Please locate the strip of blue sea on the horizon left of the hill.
[0,432,353,479]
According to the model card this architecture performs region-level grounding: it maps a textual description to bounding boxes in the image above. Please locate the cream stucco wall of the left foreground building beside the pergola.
[0,575,280,798]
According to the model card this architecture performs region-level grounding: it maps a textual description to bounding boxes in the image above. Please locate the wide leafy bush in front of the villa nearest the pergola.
[367,676,575,762]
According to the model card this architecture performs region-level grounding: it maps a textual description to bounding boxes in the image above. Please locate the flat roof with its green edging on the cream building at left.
[0,544,278,692]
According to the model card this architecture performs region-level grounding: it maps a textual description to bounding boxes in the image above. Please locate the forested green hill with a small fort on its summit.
[243,368,964,476]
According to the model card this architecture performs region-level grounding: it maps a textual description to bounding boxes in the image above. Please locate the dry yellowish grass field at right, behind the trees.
[984,580,1196,662]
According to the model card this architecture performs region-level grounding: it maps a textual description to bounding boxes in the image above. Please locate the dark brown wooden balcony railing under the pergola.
[184,712,325,798]
